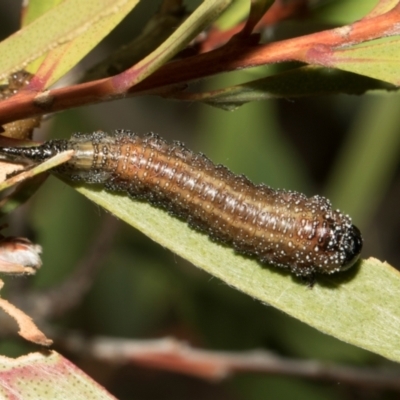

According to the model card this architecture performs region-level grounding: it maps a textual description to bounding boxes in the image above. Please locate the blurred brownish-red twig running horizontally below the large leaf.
[56,334,400,391]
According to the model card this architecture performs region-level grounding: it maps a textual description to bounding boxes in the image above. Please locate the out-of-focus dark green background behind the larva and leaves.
[0,0,400,400]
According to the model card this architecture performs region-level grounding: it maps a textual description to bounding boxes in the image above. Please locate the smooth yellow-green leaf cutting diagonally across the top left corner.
[0,0,139,80]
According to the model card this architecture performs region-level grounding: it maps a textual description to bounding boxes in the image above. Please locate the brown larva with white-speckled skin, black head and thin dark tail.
[0,131,362,277]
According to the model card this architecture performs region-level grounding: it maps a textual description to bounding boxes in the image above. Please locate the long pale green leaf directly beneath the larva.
[73,187,400,361]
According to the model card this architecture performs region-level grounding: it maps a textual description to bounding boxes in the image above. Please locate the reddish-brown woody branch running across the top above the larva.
[0,5,400,124]
